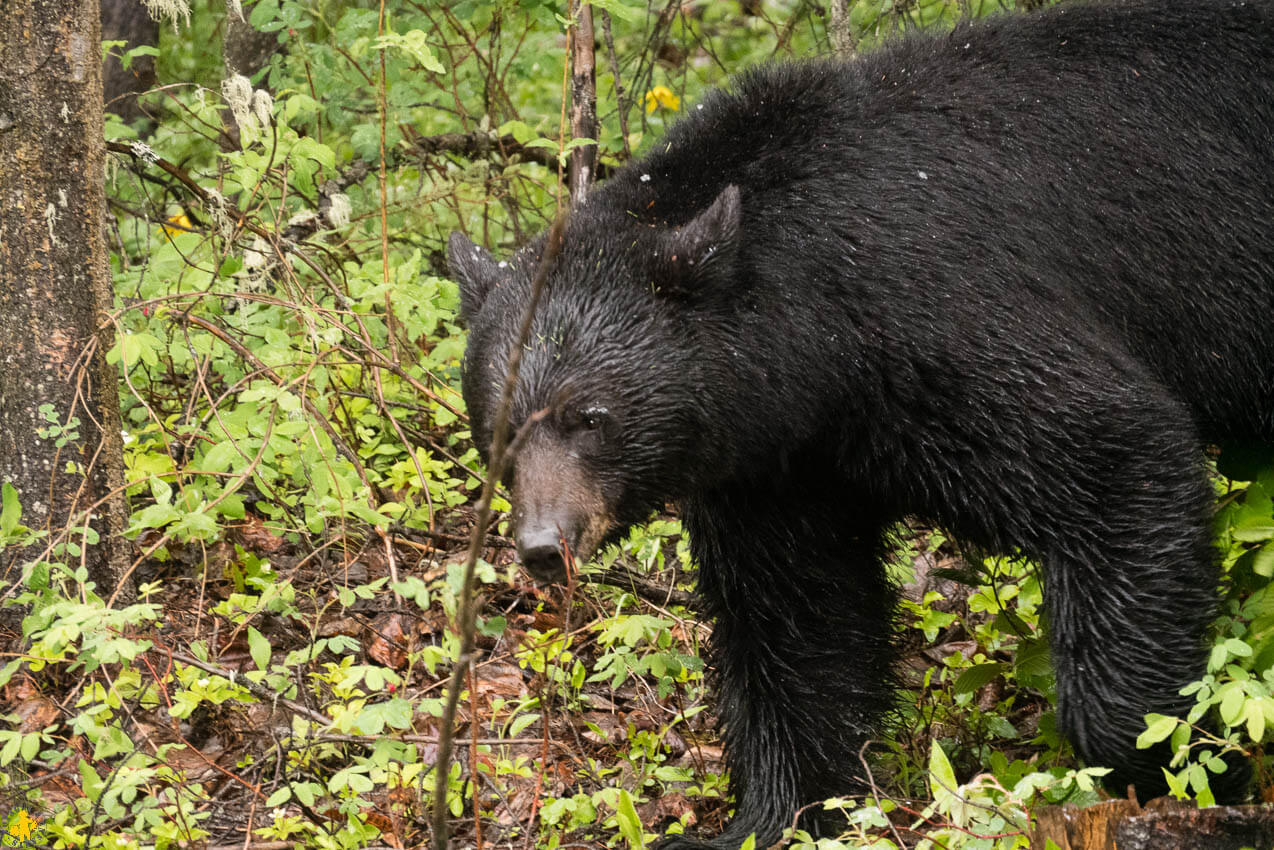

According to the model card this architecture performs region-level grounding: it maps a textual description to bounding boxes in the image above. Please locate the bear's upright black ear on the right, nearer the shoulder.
[657,185,743,294]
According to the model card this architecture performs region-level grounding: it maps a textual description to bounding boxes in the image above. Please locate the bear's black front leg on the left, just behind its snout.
[660,465,894,850]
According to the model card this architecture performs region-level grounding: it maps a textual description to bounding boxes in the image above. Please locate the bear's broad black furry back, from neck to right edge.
[595,1,1274,437]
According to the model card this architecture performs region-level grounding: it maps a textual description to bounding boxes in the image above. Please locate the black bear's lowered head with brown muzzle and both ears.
[448,186,741,581]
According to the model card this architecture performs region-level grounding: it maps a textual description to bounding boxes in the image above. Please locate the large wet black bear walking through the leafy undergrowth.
[450,0,1274,847]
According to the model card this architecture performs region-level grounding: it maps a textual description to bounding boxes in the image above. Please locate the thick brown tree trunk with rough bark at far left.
[0,0,129,596]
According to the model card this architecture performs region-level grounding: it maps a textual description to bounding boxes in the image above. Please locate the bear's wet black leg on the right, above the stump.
[1037,404,1251,803]
